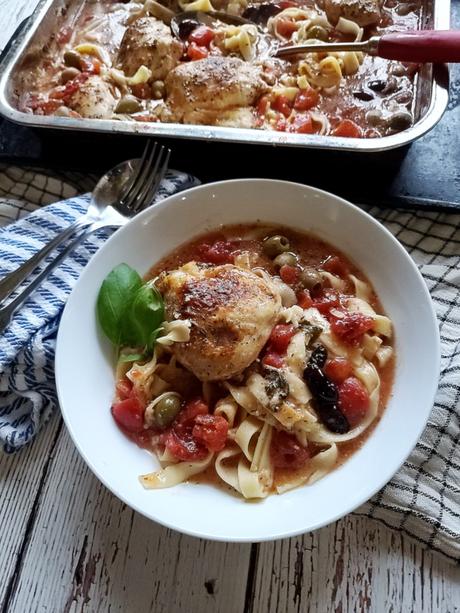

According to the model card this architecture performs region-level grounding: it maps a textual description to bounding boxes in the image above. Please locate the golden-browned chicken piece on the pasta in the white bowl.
[157,262,281,381]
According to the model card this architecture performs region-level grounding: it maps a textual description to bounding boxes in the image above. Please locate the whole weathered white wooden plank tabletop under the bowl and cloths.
[0,0,460,613]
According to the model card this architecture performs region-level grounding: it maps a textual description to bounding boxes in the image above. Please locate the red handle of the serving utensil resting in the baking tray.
[377,30,460,63]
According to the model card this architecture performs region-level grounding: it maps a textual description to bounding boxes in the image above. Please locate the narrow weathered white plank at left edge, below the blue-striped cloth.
[0,415,61,609]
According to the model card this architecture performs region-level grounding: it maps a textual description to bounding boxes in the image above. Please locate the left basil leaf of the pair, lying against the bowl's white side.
[96,264,142,345]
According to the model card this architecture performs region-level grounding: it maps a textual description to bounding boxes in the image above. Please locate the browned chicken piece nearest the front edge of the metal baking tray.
[165,56,268,121]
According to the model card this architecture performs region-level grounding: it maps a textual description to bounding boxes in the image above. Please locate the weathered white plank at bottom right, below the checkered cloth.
[251,516,460,613]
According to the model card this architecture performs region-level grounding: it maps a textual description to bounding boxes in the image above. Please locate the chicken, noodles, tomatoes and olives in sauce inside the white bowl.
[103,225,394,499]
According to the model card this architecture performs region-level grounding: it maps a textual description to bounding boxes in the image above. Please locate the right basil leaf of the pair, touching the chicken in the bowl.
[122,283,164,351]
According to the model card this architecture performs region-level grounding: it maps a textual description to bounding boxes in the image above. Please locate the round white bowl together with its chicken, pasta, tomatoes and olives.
[56,180,439,541]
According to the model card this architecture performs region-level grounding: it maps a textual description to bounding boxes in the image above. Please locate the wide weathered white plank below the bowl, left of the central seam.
[6,433,251,613]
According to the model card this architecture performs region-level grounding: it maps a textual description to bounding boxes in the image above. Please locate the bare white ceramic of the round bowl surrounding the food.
[56,179,439,541]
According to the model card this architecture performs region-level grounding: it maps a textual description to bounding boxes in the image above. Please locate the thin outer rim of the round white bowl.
[55,178,441,543]
